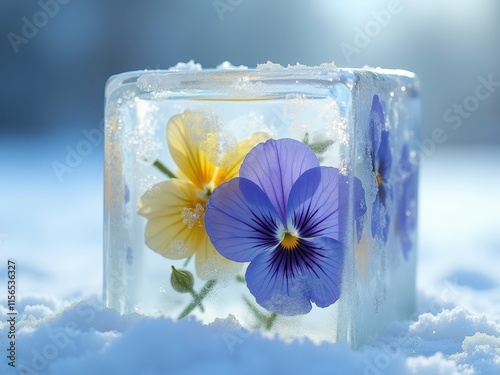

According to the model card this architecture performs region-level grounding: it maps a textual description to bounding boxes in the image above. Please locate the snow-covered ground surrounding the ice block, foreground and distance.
[0,142,500,375]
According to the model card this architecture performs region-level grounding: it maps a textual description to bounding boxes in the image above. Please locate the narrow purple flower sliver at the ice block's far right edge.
[397,145,418,259]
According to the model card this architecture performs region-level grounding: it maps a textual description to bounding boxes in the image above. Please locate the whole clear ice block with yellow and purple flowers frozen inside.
[104,63,420,347]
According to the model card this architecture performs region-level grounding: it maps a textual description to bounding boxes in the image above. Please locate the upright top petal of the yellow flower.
[167,110,216,191]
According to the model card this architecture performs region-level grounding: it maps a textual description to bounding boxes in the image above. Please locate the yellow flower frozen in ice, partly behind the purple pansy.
[138,110,269,279]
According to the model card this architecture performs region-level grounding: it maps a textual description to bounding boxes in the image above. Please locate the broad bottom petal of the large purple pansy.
[245,237,344,315]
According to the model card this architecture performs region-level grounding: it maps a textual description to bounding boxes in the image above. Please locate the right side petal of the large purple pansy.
[287,167,347,240]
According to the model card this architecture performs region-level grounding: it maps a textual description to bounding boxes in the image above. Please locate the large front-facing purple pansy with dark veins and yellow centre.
[205,139,364,315]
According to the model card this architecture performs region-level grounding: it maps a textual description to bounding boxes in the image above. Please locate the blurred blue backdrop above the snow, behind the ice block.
[0,0,500,143]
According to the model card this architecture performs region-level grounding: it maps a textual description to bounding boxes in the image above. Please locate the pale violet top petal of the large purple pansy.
[240,139,319,225]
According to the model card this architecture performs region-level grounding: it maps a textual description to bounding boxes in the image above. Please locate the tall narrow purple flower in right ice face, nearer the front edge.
[370,95,392,243]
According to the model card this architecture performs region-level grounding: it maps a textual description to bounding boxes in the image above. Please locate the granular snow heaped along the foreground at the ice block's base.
[0,298,500,375]
